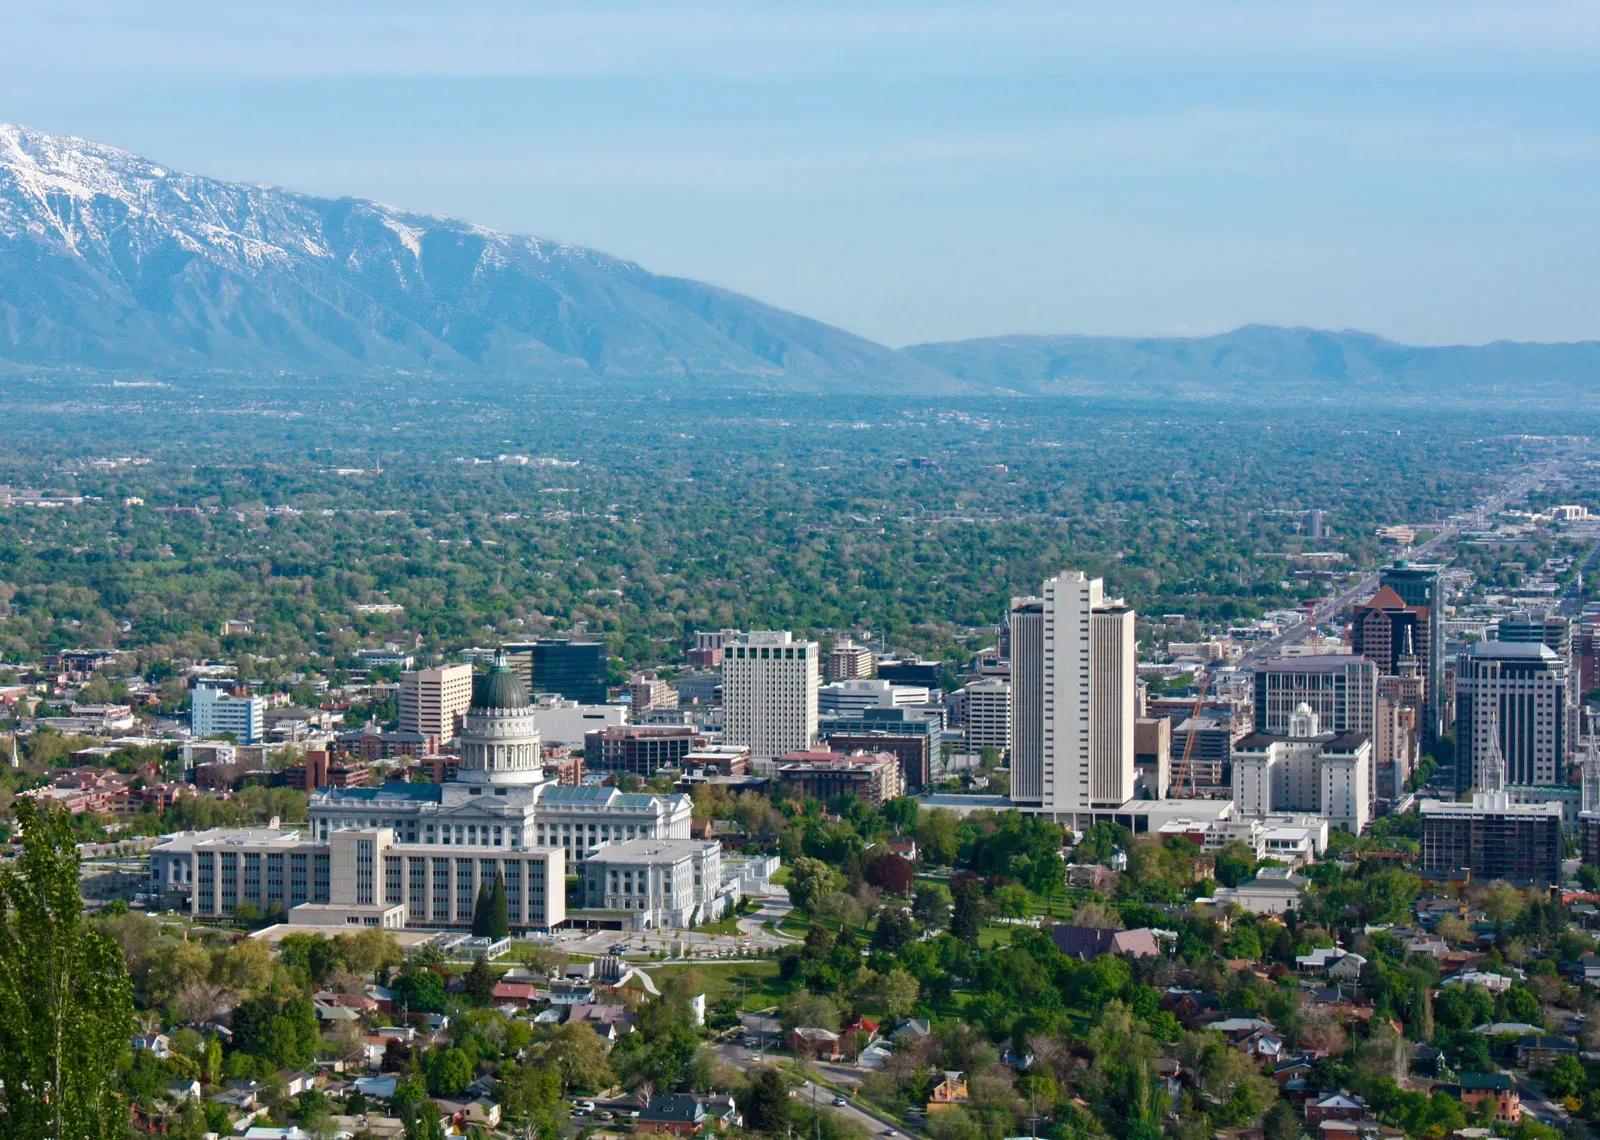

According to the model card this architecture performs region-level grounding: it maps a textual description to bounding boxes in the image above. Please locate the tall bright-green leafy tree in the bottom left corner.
[0,801,133,1140]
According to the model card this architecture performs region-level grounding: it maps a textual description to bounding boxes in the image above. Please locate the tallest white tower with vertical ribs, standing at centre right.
[1011,572,1136,823]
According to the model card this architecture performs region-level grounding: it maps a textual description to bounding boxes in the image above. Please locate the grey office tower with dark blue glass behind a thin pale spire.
[1456,642,1571,793]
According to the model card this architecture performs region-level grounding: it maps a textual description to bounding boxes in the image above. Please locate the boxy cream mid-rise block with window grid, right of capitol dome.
[722,629,821,764]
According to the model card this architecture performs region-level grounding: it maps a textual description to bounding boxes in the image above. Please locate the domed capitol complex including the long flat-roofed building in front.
[150,661,731,930]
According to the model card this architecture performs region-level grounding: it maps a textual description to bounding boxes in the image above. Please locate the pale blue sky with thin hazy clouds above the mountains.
[0,0,1600,346]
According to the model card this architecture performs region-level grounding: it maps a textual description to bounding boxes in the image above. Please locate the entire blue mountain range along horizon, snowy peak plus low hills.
[0,125,1600,397]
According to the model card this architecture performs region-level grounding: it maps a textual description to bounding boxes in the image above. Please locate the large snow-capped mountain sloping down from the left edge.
[0,125,958,392]
